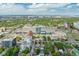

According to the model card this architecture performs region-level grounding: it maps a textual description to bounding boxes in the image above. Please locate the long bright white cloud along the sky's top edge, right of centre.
[29,3,67,8]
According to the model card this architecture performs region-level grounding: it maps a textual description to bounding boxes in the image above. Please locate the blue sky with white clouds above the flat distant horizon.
[0,3,79,16]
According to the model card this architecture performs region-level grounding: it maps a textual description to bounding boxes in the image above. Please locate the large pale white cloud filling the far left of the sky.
[0,3,26,15]
